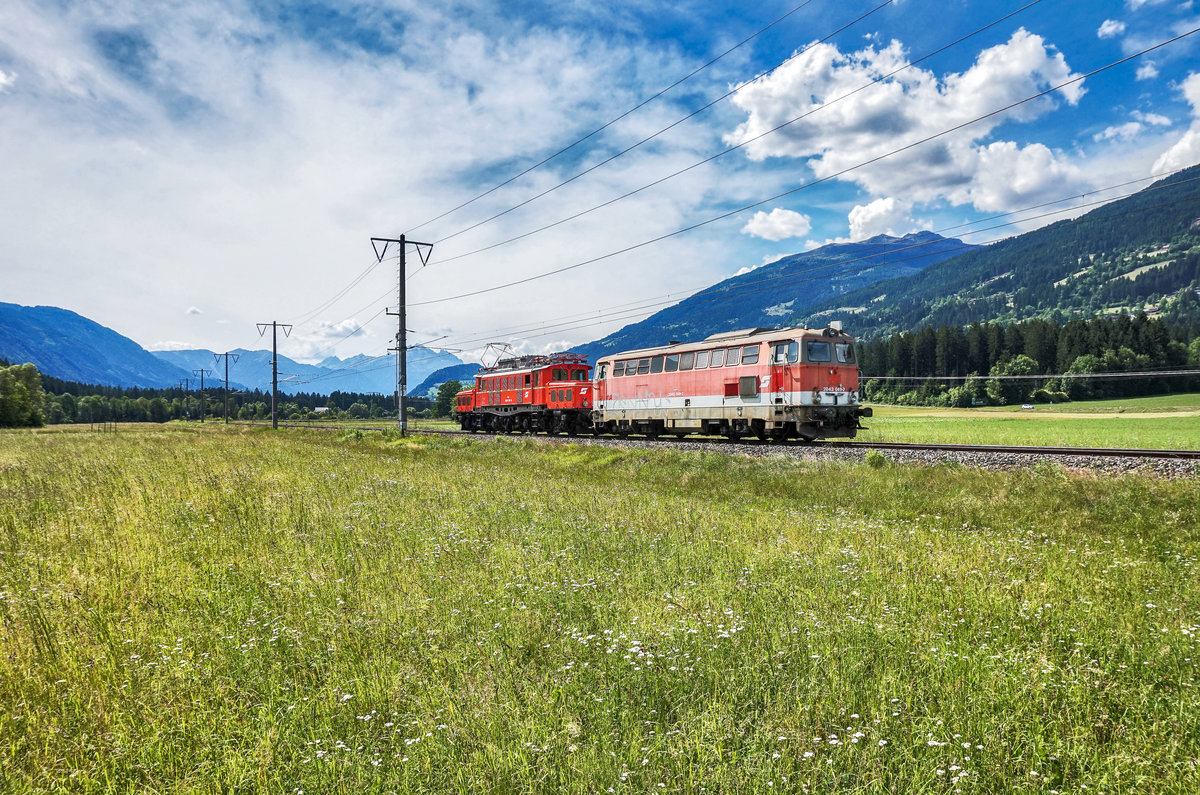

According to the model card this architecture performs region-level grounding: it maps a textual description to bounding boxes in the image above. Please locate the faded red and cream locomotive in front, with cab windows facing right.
[592,323,871,441]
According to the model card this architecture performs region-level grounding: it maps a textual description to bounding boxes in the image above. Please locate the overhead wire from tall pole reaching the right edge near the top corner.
[410,28,1200,306]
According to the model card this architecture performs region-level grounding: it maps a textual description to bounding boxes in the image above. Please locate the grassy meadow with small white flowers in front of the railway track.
[0,425,1200,794]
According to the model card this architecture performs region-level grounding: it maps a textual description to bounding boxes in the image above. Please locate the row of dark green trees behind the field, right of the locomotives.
[858,313,1200,406]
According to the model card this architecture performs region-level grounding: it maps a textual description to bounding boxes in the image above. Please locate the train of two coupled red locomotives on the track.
[457,323,871,441]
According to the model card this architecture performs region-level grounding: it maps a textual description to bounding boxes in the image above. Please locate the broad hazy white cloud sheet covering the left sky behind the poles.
[0,0,739,357]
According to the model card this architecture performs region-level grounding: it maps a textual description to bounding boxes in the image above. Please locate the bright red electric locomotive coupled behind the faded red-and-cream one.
[455,353,592,435]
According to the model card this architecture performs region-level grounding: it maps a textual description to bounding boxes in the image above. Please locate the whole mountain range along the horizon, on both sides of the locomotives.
[0,166,1200,395]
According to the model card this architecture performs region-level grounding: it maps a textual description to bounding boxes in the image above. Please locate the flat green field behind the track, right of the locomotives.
[857,395,1200,450]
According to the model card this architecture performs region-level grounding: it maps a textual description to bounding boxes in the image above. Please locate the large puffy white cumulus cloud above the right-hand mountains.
[726,29,1086,210]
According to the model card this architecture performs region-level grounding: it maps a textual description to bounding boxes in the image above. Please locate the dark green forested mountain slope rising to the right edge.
[790,166,1200,336]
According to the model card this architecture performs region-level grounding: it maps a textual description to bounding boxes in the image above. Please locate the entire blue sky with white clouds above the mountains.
[0,0,1200,374]
